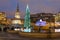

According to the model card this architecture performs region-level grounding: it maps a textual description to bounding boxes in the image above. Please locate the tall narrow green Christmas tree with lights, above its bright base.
[24,5,30,28]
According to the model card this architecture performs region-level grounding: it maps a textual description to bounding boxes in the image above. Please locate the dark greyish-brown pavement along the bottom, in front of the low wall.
[0,32,60,40]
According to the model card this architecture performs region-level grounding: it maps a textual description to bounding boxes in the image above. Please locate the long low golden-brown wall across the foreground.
[19,32,60,39]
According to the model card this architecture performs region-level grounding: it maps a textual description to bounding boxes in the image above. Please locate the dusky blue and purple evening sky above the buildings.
[0,0,60,18]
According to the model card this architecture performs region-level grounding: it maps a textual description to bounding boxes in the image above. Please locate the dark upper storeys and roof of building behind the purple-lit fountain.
[31,13,55,23]
